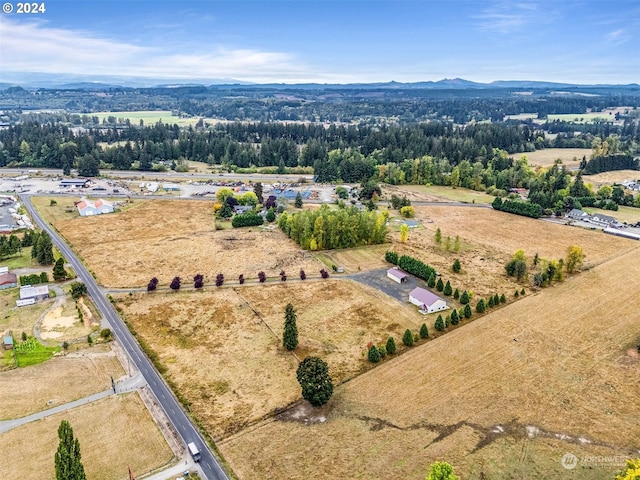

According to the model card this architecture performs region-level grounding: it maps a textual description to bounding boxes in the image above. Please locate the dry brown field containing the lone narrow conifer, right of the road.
[118,279,422,438]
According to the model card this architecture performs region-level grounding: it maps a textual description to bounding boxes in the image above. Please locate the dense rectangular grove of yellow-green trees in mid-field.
[278,205,387,250]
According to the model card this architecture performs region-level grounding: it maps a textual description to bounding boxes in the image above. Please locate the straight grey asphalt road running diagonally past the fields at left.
[20,195,228,480]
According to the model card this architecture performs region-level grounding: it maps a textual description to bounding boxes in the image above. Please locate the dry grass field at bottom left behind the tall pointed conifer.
[0,393,173,480]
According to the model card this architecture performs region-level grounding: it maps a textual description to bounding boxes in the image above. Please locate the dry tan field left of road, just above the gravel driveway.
[0,345,124,420]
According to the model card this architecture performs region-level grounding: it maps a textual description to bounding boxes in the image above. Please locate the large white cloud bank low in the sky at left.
[0,18,340,82]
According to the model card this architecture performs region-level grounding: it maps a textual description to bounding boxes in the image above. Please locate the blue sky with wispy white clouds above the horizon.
[0,0,640,84]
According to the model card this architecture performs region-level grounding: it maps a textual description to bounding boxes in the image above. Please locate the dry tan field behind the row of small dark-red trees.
[39,199,322,288]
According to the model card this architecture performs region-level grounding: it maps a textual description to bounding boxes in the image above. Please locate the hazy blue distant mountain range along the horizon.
[0,72,640,90]
